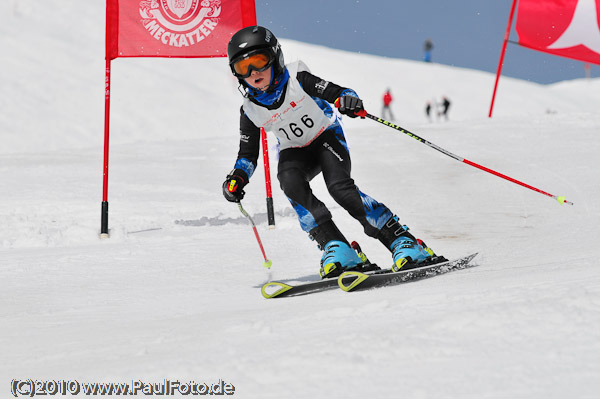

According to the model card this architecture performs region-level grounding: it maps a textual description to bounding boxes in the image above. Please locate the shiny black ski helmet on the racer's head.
[227,26,285,85]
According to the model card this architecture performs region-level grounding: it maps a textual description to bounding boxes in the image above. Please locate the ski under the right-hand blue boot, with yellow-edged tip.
[337,253,477,292]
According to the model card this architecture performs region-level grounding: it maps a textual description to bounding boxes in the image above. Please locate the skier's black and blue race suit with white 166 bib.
[235,62,393,237]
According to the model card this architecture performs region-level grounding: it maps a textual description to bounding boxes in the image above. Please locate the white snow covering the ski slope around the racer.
[0,0,600,398]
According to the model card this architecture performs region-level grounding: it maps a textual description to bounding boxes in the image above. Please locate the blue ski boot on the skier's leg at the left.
[309,220,363,278]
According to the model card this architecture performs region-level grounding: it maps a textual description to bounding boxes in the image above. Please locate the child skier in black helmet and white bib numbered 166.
[223,26,434,278]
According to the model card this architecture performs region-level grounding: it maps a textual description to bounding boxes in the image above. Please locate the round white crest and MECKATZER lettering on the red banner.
[139,0,221,48]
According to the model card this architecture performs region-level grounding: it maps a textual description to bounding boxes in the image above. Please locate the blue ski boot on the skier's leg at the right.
[377,216,435,272]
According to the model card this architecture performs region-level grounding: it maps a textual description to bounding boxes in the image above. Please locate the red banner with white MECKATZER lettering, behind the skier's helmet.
[106,0,256,60]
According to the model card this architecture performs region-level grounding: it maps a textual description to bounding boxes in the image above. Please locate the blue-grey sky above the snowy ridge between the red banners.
[256,0,600,83]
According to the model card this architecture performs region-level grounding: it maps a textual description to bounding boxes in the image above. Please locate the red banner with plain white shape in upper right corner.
[516,0,600,64]
